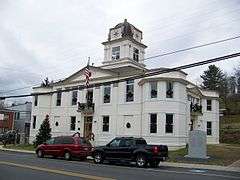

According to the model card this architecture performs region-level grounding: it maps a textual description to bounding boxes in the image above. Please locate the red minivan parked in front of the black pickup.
[36,136,92,160]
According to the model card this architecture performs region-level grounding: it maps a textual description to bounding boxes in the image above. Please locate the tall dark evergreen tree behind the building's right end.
[200,65,228,97]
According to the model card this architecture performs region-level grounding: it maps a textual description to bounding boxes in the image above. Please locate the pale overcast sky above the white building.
[0,0,240,103]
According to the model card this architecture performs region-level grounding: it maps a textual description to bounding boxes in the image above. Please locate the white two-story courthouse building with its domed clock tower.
[30,20,219,148]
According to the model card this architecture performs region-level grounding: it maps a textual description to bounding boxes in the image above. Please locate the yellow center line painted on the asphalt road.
[0,161,115,180]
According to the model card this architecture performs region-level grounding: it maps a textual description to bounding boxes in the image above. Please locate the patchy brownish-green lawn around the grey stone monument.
[168,144,240,166]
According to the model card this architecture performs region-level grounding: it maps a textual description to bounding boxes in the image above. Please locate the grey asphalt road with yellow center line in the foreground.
[0,151,240,180]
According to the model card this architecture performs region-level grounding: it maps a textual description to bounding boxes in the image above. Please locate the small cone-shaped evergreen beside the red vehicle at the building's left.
[35,115,51,146]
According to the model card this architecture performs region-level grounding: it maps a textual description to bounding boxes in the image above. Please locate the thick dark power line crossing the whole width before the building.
[0,52,240,99]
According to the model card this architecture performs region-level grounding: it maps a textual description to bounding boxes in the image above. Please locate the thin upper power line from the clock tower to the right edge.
[143,35,240,61]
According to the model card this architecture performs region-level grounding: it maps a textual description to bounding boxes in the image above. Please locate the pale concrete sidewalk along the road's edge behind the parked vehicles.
[0,145,240,172]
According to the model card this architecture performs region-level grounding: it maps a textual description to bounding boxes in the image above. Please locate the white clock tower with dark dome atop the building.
[101,19,147,72]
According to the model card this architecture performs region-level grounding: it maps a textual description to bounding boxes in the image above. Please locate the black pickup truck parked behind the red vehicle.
[92,137,168,167]
